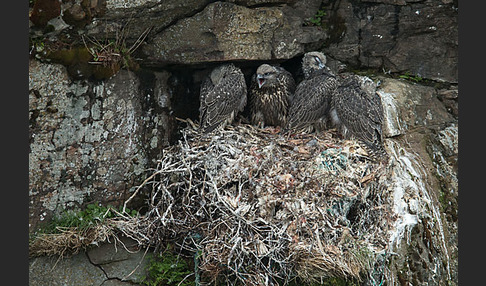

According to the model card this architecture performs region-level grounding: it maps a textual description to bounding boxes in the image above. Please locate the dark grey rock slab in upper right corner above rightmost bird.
[325,0,458,83]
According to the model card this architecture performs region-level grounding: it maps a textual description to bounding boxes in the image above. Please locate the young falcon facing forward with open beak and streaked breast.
[249,65,295,127]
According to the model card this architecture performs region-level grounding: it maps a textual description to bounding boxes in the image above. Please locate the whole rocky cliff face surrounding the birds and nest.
[29,0,458,285]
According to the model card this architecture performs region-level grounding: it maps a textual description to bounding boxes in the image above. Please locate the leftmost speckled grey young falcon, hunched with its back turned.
[199,64,247,133]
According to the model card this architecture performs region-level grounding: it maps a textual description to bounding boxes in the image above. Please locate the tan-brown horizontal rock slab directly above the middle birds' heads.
[143,2,325,65]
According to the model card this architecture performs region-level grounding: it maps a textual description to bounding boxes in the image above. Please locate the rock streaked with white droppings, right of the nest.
[377,78,458,285]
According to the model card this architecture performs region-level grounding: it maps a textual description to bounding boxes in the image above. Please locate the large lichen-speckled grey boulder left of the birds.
[29,60,172,231]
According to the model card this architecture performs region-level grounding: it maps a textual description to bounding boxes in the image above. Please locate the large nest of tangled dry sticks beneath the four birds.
[29,122,393,285]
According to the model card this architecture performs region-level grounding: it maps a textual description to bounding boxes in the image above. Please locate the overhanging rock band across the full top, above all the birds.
[30,0,458,83]
